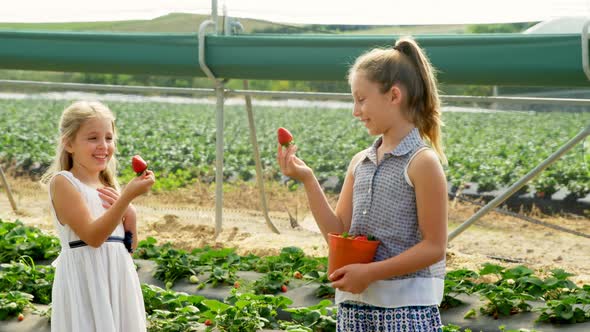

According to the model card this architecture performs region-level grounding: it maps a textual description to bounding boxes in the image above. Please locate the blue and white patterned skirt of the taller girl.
[336,302,443,332]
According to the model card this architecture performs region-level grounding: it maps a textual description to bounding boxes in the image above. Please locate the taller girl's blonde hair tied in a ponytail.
[348,37,447,164]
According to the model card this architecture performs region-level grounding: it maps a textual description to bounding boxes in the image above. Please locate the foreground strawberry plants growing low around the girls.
[0,220,590,332]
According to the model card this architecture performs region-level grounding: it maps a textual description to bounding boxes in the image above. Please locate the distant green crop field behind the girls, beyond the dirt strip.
[0,99,590,198]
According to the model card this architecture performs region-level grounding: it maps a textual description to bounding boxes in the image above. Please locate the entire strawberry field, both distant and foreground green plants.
[0,99,590,331]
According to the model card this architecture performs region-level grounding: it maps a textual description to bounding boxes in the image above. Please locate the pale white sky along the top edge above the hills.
[0,0,590,25]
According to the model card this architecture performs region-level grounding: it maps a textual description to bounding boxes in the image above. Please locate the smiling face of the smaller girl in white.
[66,118,115,174]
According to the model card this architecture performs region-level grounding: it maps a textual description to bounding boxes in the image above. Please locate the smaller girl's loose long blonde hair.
[41,101,119,190]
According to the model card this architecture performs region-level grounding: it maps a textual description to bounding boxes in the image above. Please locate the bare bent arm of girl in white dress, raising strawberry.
[51,171,155,247]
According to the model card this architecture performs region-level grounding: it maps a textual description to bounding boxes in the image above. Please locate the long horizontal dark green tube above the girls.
[0,31,590,86]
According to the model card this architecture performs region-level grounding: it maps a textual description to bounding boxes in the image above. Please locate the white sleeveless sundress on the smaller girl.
[50,171,146,332]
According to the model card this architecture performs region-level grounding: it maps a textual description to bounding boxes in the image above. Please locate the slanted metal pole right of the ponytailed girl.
[448,125,590,242]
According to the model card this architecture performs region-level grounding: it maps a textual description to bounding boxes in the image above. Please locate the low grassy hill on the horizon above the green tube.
[0,13,468,35]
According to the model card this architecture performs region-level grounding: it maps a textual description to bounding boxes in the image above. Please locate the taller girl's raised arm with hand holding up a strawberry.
[278,145,366,241]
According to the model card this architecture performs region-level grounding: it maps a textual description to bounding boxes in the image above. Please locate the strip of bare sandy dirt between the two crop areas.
[0,178,590,285]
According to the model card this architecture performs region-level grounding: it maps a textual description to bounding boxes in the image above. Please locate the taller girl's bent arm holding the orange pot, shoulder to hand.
[367,149,448,281]
